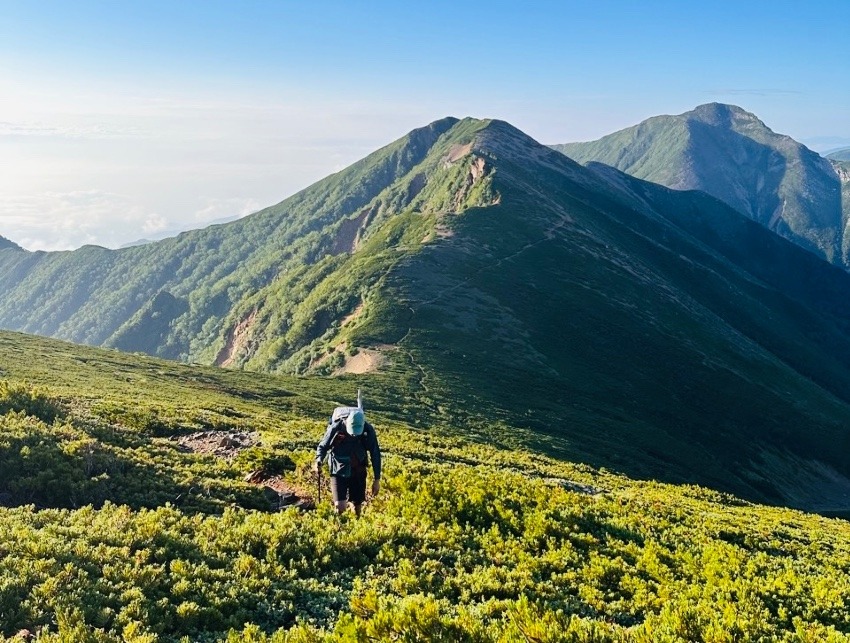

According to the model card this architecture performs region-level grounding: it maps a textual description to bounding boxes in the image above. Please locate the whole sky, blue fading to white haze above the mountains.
[0,0,850,250]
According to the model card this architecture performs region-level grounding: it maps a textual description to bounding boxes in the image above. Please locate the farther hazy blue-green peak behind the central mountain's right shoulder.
[553,103,850,269]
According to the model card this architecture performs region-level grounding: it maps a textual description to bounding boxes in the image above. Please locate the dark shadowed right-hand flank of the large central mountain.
[336,123,850,507]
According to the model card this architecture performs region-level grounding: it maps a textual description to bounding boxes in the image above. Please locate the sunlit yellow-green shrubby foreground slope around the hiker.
[0,332,850,642]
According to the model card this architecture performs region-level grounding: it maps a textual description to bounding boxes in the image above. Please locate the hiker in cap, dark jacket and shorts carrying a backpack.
[313,407,381,517]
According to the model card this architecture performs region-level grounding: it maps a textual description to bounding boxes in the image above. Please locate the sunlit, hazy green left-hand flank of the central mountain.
[0,119,468,366]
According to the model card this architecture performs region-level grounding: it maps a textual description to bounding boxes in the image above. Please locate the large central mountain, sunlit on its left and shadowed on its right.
[6,118,850,509]
